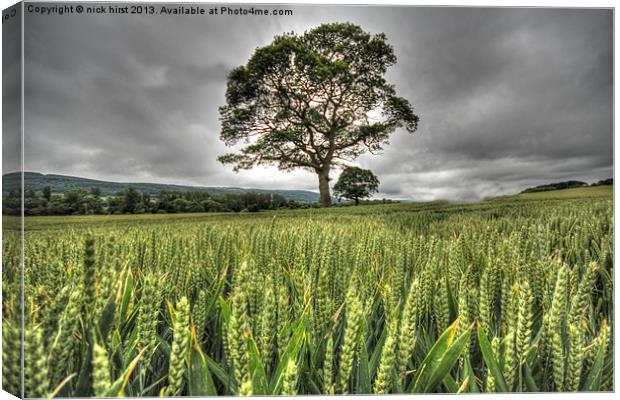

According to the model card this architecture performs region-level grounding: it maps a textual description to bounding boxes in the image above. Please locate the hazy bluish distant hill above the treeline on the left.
[2,172,319,202]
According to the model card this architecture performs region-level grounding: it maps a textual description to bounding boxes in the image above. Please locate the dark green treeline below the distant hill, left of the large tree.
[2,186,318,215]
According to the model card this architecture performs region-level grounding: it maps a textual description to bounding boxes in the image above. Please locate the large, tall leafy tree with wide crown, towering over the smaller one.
[218,23,418,206]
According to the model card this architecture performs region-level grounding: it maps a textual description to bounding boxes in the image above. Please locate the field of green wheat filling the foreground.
[3,187,613,397]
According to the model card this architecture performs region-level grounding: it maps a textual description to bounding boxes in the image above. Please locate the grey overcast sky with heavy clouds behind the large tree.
[12,4,613,200]
